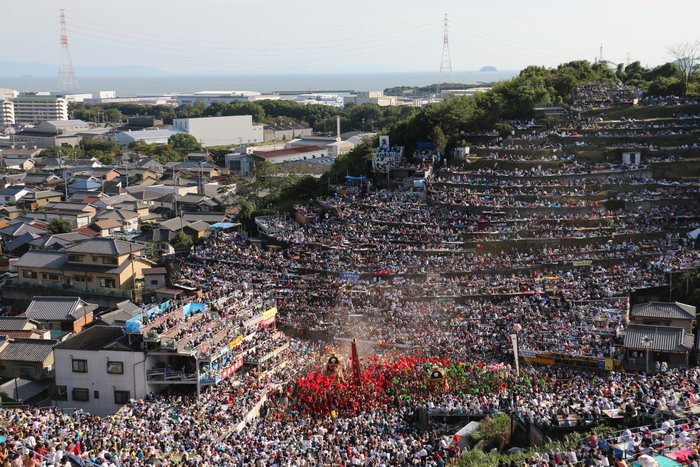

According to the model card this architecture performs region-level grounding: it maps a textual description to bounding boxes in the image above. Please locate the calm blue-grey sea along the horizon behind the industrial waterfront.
[0,70,518,97]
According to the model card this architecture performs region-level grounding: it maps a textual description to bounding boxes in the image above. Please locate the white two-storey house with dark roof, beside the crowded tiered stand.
[54,326,147,417]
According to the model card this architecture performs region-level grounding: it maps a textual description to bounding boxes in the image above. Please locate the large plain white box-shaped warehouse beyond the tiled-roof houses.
[173,115,264,146]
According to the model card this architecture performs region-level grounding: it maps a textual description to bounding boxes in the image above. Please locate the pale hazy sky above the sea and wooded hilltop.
[0,0,700,75]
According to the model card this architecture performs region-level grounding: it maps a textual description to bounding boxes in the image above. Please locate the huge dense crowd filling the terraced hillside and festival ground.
[0,100,700,467]
